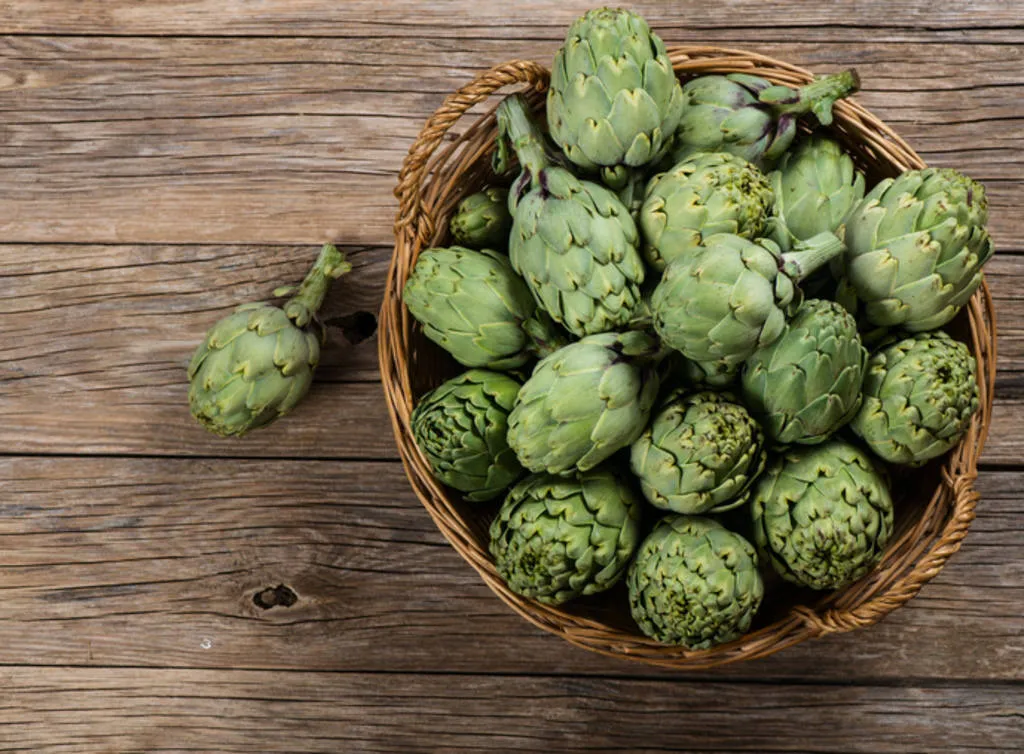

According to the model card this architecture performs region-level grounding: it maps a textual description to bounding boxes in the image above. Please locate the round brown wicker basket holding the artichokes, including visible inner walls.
[380,47,995,669]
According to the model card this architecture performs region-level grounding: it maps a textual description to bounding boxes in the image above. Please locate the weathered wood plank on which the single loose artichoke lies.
[0,245,1024,464]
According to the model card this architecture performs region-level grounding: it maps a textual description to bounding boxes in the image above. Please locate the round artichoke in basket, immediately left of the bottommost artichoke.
[490,469,640,604]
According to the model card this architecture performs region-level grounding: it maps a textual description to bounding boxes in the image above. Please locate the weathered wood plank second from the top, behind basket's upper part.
[0,36,1024,245]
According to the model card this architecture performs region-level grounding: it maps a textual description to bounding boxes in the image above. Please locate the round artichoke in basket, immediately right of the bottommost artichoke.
[751,439,893,589]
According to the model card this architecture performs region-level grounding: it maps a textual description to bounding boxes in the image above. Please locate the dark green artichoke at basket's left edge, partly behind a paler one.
[410,369,522,500]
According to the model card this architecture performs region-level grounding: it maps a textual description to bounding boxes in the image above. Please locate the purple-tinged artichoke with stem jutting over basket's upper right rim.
[672,71,860,166]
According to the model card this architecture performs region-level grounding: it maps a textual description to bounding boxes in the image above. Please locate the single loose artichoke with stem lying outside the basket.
[188,244,352,436]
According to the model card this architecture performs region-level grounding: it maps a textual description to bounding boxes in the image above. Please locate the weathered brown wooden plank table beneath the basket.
[0,0,1024,753]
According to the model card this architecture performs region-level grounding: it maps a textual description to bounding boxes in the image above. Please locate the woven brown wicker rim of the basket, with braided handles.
[378,45,996,670]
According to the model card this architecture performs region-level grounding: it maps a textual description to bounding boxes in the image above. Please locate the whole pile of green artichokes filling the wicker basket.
[404,8,992,650]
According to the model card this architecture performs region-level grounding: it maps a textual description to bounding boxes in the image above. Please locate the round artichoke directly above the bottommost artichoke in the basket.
[630,391,766,513]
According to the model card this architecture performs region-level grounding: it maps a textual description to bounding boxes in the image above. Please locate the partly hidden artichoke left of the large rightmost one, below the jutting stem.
[768,134,864,249]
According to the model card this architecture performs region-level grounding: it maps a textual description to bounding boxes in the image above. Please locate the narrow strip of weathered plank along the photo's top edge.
[0,0,1020,41]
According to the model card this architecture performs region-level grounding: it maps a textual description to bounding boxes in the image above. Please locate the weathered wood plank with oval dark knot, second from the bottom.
[0,458,1024,682]
